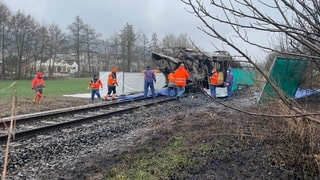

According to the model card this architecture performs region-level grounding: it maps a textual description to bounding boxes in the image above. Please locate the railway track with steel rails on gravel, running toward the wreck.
[0,97,175,142]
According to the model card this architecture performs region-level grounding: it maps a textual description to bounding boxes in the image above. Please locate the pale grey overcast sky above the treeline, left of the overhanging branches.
[0,0,268,60]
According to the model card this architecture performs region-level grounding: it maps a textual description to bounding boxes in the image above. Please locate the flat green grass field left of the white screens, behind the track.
[0,78,90,99]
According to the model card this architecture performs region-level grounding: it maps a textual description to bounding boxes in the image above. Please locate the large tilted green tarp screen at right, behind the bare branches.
[258,57,307,103]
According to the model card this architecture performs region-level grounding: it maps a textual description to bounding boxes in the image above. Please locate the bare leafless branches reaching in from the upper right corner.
[182,0,320,122]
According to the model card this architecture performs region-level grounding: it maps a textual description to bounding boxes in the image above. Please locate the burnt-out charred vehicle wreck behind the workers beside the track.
[152,49,240,91]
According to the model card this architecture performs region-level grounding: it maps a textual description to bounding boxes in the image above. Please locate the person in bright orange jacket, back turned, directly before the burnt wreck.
[173,63,189,100]
